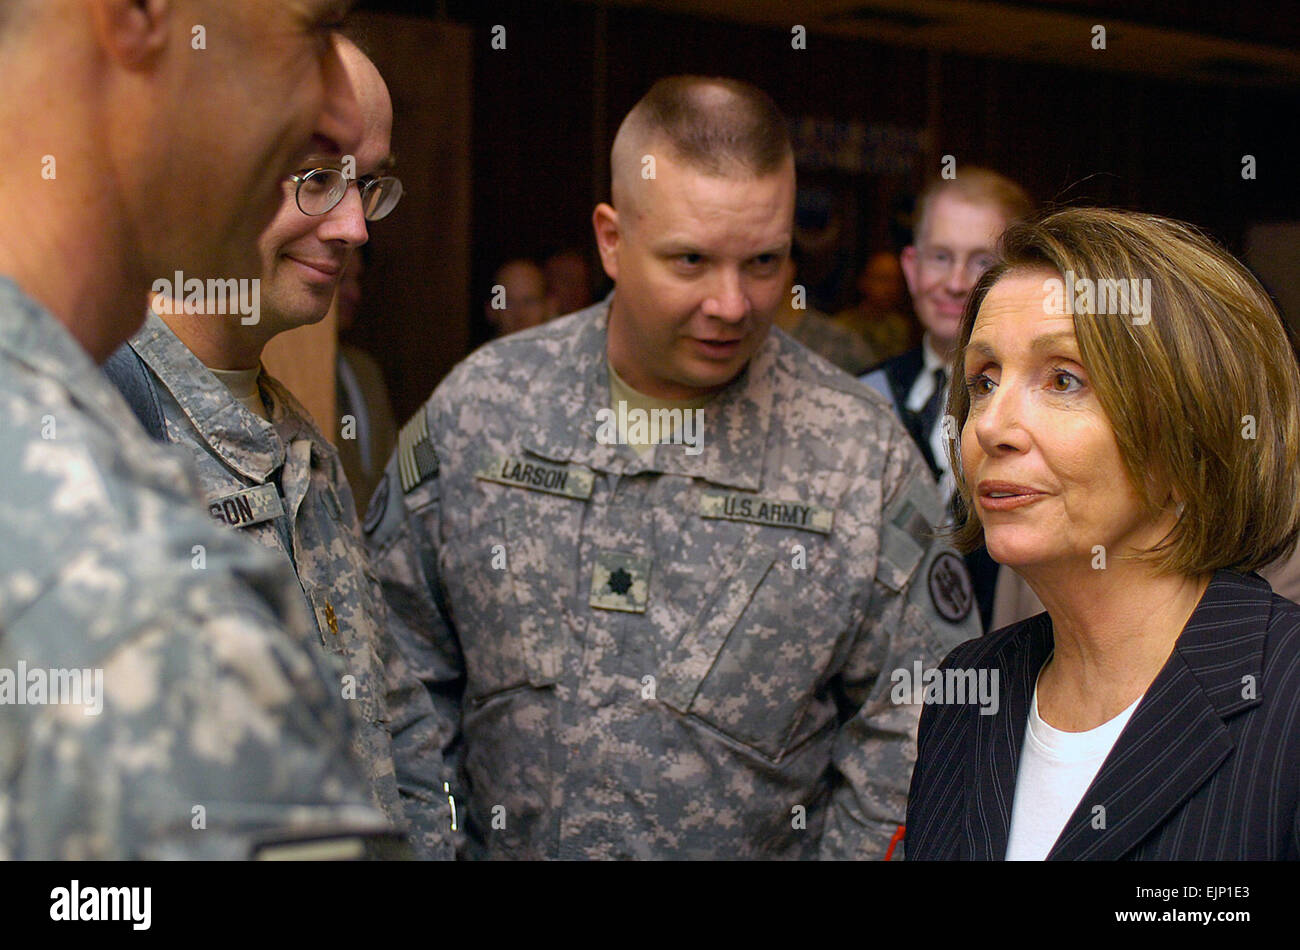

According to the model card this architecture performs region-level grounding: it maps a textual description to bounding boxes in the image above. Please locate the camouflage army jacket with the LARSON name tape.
[367,300,979,859]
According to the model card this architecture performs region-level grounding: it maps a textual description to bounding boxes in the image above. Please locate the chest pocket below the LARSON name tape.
[439,519,563,702]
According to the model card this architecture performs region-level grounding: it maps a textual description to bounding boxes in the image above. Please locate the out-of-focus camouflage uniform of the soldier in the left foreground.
[0,278,390,860]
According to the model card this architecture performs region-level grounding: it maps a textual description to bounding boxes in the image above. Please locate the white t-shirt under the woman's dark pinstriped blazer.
[1006,684,1141,860]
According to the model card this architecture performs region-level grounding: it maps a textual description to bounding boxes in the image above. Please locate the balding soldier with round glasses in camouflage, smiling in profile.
[105,40,450,858]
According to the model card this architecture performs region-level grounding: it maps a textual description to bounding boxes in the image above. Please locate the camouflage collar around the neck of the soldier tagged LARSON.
[523,294,779,491]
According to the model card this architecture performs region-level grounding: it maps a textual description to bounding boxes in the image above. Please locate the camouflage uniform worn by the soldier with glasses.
[130,313,451,858]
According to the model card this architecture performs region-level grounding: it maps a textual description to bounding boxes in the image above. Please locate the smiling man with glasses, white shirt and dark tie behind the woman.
[862,166,1032,630]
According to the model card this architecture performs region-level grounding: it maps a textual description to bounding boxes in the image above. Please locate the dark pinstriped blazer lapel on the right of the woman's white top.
[1048,571,1271,860]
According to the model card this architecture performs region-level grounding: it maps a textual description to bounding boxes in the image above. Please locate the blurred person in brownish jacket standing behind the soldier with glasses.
[334,244,398,517]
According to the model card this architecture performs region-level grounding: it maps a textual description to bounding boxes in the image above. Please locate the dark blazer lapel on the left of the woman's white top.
[965,613,1053,860]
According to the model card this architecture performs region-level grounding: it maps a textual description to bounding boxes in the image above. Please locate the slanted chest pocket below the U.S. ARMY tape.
[657,545,853,762]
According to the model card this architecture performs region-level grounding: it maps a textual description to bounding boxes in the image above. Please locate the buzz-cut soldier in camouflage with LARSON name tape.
[365,77,979,858]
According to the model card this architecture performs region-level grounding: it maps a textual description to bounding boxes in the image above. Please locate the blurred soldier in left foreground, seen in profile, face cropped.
[0,0,391,859]
